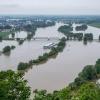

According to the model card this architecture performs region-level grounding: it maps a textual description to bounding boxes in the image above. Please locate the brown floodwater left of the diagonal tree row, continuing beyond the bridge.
[0,23,63,70]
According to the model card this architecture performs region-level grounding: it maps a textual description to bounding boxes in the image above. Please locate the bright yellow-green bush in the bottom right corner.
[72,83,100,100]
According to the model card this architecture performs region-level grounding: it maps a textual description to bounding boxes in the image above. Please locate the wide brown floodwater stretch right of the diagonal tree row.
[25,41,100,91]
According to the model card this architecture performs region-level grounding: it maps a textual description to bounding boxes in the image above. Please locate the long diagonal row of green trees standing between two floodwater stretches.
[18,38,66,70]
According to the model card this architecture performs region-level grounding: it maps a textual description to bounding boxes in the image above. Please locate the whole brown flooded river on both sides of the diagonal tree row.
[0,24,100,91]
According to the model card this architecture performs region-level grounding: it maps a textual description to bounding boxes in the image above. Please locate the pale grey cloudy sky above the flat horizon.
[0,0,100,15]
